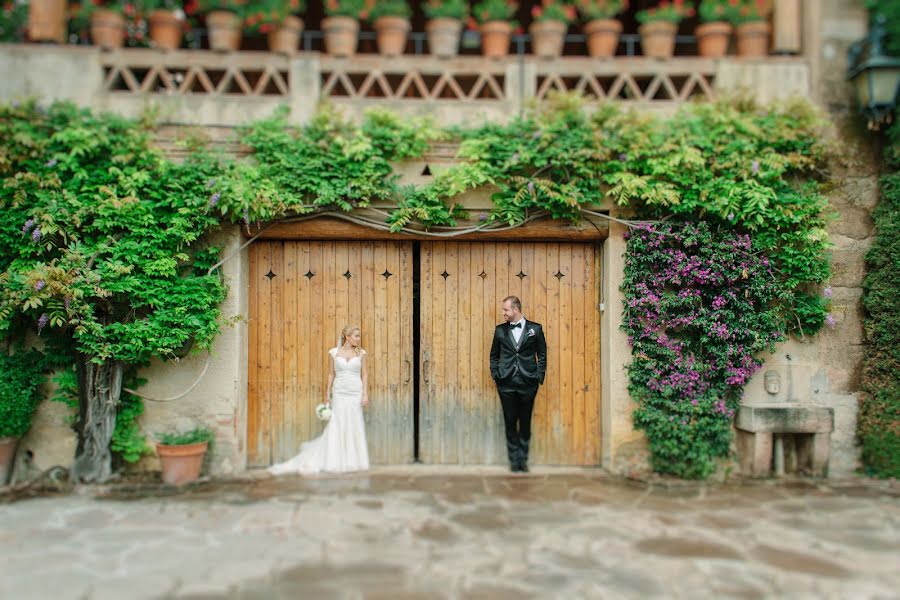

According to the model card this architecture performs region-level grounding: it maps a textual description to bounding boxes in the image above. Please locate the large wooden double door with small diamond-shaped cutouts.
[247,241,600,466]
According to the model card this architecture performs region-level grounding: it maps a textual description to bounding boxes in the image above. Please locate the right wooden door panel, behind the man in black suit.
[419,242,600,465]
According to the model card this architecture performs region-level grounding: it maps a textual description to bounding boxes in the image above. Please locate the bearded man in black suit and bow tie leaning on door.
[491,296,547,473]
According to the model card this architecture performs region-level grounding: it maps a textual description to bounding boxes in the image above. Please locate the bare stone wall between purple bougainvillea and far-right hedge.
[745,0,878,477]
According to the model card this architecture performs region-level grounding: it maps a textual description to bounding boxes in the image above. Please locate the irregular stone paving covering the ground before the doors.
[0,468,900,600]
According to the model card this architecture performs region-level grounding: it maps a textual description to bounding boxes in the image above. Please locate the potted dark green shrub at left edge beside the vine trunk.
[0,344,45,486]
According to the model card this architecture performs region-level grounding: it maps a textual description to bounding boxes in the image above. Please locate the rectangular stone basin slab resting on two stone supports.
[734,402,834,433]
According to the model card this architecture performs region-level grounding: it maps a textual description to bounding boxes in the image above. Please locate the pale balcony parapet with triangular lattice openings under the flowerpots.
[0,42,811,126]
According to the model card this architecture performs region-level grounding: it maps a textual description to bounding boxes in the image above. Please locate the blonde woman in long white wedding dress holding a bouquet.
[269,325,369,475]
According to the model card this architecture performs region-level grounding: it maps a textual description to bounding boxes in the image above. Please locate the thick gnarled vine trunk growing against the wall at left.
[72,355,123,483]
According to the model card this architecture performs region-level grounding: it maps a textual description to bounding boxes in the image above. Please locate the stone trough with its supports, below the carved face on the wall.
[734,402,834,477]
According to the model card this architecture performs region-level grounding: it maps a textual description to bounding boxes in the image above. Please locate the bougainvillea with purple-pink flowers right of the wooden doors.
[622,221,784,478]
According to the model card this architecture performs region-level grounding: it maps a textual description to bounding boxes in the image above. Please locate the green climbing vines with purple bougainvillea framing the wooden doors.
[0,95,829,477]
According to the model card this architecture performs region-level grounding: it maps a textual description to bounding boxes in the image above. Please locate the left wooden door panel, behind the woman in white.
[247,241,414,466]
